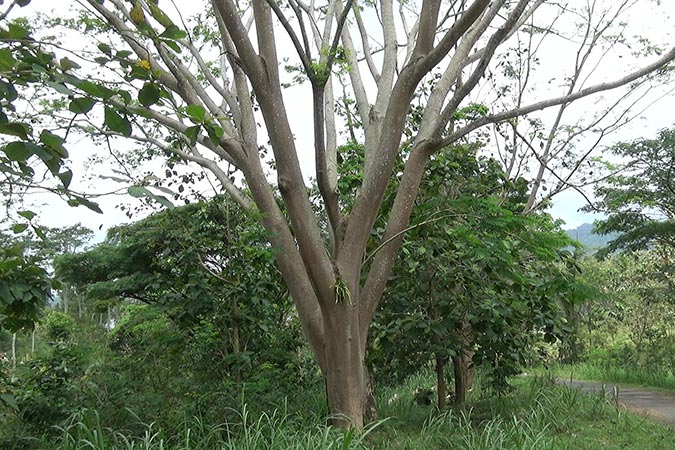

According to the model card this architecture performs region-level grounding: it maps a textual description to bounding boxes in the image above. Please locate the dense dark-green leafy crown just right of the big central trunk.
[371,147,581,389]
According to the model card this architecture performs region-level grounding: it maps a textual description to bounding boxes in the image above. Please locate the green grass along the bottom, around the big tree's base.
[35,376,675,450]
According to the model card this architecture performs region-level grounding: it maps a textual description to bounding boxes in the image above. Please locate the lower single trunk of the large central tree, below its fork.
[325,302,367,428]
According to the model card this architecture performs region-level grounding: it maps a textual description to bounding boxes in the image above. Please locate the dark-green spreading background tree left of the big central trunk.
[56,198,293,378]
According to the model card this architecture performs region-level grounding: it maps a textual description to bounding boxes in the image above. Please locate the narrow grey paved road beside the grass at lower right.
[558,378,675,426]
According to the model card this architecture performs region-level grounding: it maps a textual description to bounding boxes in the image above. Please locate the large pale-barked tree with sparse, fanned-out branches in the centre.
[9,0,675,427]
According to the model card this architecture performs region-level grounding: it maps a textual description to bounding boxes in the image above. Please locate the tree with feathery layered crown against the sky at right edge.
[587,129,675,256]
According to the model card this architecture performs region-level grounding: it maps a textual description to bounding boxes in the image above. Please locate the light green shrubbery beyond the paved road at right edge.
[570,246,675,381]
